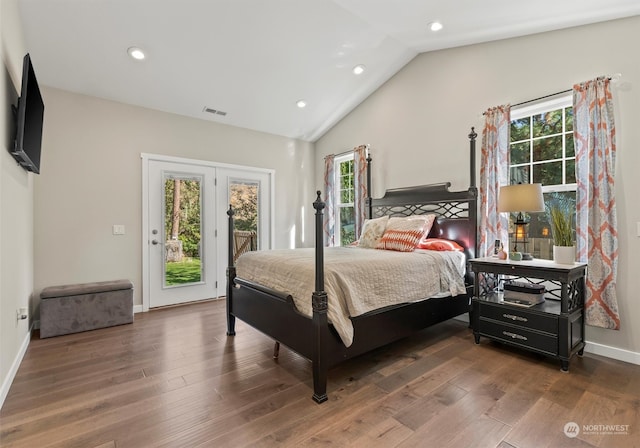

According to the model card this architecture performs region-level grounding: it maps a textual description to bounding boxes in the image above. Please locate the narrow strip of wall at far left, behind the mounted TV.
[0,0,33,406]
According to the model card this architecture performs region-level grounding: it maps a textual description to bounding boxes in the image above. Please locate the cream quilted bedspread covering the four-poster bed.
[236,247,466,347]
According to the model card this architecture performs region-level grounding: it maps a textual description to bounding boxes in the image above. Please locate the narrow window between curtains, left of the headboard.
[334,152,356,246]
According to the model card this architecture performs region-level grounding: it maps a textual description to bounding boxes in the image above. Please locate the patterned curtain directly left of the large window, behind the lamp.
[479,104,511,257]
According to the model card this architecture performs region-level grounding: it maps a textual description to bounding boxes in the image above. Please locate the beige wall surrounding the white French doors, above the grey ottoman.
[34,88,315,304]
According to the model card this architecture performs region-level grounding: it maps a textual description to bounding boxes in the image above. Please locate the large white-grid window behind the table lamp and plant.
[509,94,576,259]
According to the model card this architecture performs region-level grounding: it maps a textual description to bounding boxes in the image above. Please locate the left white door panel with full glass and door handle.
[148,160,217,308]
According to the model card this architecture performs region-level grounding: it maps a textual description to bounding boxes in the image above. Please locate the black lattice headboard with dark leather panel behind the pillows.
[369,182,478,280]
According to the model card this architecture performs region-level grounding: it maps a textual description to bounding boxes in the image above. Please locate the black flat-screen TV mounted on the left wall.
[11,53,44,174]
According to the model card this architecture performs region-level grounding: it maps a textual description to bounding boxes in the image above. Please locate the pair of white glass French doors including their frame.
[142,154,273,311]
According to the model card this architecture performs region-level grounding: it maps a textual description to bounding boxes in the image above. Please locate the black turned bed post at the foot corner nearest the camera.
[311,191,329,403]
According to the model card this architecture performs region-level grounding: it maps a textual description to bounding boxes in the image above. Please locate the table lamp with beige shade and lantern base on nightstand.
[498,184,544,260]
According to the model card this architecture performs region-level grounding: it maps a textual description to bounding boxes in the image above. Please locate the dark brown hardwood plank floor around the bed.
[0,301,640,448]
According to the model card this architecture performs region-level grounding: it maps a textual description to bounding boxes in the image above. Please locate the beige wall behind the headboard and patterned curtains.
[316,17,640,362]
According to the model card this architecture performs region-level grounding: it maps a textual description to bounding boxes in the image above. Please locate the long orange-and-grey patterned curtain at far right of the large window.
[573,78,620,330]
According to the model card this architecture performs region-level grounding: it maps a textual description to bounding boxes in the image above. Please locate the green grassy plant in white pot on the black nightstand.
[547,197,576,264]
